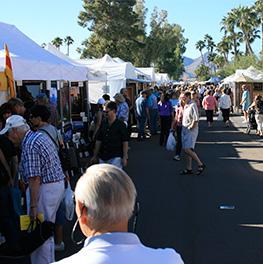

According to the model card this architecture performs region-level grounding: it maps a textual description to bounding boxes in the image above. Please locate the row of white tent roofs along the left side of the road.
[0,22,169,102]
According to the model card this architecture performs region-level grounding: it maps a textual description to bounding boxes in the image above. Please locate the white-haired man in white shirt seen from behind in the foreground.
[53,164,183,264]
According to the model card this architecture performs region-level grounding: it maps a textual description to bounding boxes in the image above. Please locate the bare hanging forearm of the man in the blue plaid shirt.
[28,176,40,220]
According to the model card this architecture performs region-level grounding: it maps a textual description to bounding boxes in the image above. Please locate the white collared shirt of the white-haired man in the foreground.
[52,232,183,264]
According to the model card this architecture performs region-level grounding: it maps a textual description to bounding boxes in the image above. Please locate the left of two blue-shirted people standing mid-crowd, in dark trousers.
[135,91,147,141]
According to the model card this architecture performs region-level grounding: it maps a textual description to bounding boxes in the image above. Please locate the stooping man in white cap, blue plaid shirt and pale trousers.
[0,115,64,264]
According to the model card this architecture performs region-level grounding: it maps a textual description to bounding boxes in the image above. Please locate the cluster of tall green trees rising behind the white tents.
[78,0,187,78]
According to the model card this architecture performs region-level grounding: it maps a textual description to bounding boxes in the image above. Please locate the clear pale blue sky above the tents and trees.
[0,0,260,58]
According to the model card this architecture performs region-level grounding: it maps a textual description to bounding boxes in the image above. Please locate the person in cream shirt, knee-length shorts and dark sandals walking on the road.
[181,92,206,175]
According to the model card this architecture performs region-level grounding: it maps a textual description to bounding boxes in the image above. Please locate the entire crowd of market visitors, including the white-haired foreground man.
[0,81,263,264]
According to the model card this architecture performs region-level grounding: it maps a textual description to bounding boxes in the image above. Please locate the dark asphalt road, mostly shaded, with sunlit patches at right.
[57,117,263,264]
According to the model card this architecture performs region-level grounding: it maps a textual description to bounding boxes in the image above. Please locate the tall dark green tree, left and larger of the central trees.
[78,0,144,61]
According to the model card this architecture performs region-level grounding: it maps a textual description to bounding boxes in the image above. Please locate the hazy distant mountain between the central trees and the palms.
[182,53,209,80]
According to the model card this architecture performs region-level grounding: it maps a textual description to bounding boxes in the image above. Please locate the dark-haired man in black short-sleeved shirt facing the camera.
[91,102,129,168]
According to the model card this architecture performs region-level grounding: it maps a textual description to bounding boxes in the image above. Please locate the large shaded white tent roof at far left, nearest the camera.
[0,22,87,81]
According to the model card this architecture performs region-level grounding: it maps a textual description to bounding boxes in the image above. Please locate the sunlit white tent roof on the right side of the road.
[223,66,263,83]
